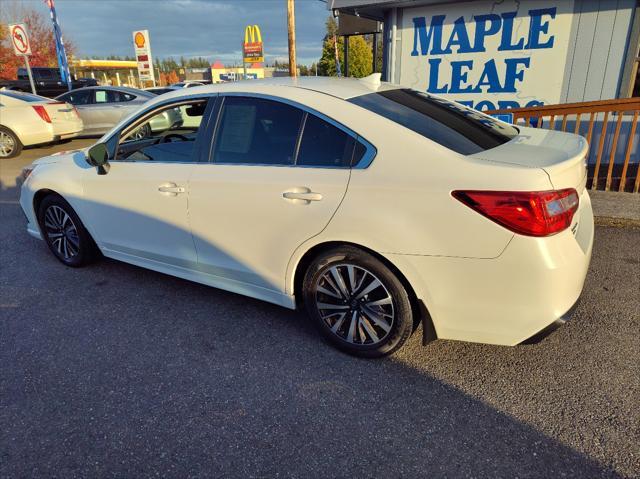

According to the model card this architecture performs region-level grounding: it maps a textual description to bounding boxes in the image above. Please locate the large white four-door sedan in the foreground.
[20,77,594,357]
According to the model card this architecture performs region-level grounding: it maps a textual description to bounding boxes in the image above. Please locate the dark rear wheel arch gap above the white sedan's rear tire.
[293,241,436,344]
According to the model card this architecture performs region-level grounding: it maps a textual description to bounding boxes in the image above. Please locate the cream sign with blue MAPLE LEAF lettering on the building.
[400,0,573,110]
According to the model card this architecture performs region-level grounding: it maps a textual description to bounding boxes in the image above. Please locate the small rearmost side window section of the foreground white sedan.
[296,113,355,168]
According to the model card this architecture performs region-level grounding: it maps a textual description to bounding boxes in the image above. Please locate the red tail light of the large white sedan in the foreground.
[452,188,579,236]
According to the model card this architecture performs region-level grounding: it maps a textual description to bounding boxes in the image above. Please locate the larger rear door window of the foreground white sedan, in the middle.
[213,96,304,165]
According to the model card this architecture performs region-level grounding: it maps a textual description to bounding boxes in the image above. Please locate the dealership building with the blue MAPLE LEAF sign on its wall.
[328,0,640,110]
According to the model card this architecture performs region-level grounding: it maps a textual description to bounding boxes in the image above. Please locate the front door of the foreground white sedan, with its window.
[83,98,215,274]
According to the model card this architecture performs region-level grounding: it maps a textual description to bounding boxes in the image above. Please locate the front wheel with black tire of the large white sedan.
[38,195,100,268]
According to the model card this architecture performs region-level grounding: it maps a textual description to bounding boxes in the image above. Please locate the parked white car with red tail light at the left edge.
[0,90,82,158]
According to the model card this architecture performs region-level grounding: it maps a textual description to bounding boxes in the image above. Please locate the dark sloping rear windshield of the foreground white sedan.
[348,89,518,155]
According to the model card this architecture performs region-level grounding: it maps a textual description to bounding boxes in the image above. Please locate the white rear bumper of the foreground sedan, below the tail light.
[386,192,594,346]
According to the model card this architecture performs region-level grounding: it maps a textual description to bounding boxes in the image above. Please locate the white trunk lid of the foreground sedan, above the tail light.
[471,126,588,195]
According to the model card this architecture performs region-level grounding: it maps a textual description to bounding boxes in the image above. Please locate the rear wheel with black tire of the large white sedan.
[302,246,413,358]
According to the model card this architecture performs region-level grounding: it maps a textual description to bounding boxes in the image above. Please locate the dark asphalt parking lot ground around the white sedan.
[0,140,640,478]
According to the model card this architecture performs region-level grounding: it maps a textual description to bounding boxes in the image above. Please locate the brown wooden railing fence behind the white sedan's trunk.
[485,97,640,193]
